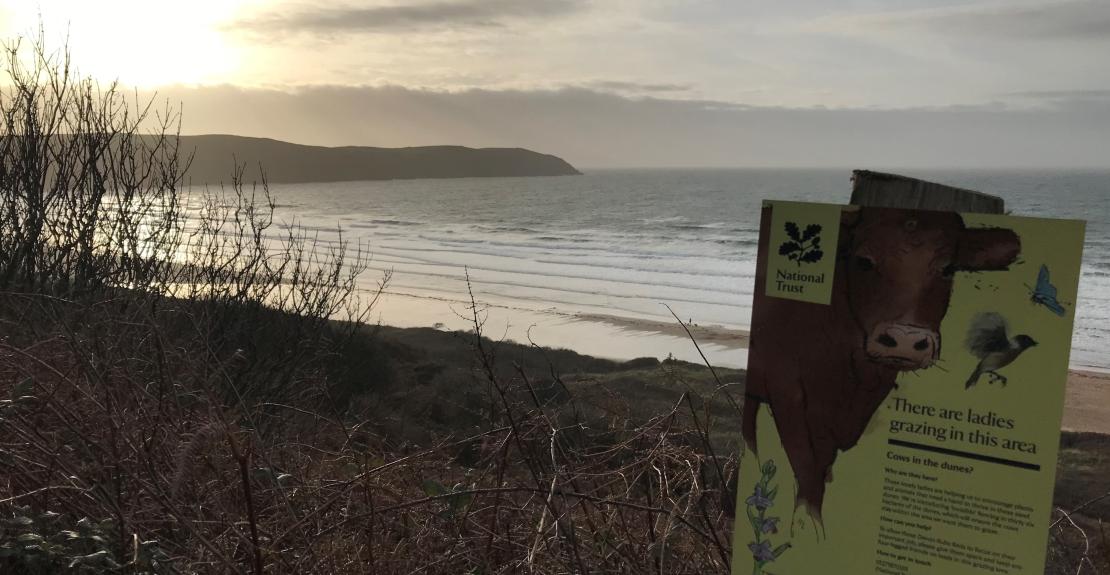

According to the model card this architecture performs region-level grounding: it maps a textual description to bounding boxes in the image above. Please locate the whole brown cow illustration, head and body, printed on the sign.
[743,208,1021,522]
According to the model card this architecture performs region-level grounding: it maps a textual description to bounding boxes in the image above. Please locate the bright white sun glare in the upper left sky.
[0,0,244,89]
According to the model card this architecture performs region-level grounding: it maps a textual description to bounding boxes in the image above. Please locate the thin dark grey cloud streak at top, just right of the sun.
[230,0,584,34]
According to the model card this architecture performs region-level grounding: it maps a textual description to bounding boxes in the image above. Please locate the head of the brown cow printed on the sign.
[837,208,1021,371]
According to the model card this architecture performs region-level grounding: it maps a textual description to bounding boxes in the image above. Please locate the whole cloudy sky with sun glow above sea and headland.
[0,0,1110,169]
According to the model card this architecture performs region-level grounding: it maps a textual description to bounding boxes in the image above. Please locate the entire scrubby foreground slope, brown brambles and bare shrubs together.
[0,32,1107,574]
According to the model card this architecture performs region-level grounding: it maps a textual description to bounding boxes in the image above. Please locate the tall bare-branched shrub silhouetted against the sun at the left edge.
[0,32,182,293]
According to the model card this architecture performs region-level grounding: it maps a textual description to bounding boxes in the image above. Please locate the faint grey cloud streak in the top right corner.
[806,0,1110,40]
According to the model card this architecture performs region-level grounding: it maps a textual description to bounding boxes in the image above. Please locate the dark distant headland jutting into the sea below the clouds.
[170,135,579,184]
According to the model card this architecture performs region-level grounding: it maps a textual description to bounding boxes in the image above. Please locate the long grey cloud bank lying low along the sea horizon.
[152,87,1110,169]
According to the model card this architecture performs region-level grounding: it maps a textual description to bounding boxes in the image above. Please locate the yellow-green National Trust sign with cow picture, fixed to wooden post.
[733,202,1083,575]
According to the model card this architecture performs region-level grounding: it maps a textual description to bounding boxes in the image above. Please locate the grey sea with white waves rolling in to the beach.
[249,169,1110,369]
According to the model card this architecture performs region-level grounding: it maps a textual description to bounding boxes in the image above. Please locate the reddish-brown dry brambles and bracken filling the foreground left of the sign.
[0,294,733,573]
